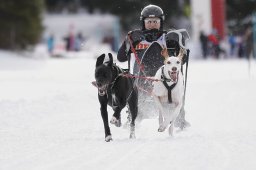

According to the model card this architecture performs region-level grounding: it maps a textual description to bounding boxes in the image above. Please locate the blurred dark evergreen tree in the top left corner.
[0,0,44,49]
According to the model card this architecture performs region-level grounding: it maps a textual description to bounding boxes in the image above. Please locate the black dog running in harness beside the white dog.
[95,53,138,142]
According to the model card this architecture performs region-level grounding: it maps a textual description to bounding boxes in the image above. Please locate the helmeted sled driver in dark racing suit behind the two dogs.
[117,5,189,129]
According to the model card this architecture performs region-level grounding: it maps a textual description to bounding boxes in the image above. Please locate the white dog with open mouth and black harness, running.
[152,48,185,136]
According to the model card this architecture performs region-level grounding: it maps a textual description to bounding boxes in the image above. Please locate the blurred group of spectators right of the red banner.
[199,26,253,59]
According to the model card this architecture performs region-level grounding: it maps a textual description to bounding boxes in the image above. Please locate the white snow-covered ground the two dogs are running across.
[0,52,256,170]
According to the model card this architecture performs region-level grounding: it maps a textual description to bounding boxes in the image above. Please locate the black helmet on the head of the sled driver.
[140,5,164,30]
